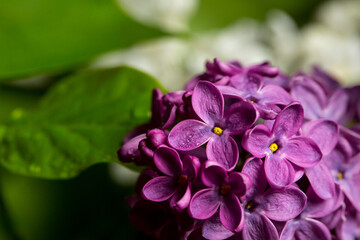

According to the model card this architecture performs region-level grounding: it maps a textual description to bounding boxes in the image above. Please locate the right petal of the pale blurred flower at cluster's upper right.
[323,89,349,122]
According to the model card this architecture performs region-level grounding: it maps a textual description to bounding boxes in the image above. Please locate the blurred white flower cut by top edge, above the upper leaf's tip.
[117,0,198,32]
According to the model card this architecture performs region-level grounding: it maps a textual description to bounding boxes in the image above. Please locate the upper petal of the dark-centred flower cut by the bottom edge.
[241,158,267,199]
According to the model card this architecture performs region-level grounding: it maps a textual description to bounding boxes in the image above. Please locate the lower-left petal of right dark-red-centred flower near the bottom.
[189,189,220,219]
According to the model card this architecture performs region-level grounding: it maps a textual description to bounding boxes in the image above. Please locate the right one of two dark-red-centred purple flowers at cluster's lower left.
[189,165,251,231]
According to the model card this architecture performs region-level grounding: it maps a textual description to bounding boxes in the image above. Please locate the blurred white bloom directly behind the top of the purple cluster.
[185,19,273,74]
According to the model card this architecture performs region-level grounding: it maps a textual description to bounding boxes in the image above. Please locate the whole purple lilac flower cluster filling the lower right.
[118,59,360,240]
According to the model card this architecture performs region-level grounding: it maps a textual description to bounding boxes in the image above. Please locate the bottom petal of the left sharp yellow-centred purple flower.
[206,134,239,171]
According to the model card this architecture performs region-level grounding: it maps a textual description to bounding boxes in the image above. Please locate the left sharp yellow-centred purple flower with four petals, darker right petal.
[168,81,257,170]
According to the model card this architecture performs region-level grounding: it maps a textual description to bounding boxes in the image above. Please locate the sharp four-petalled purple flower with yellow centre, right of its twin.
[242,102,322,188]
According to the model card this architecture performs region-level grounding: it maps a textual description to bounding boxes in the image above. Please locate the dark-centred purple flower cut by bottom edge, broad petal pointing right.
[225,158,306,240]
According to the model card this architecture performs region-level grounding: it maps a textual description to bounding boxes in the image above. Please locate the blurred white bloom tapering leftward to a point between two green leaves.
[93,37,188,90]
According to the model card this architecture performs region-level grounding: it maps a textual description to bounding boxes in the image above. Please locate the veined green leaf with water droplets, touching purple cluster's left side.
[0,67,160,179]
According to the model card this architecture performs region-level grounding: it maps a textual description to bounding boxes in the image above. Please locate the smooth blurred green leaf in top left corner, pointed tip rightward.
[0,0,163,81]
